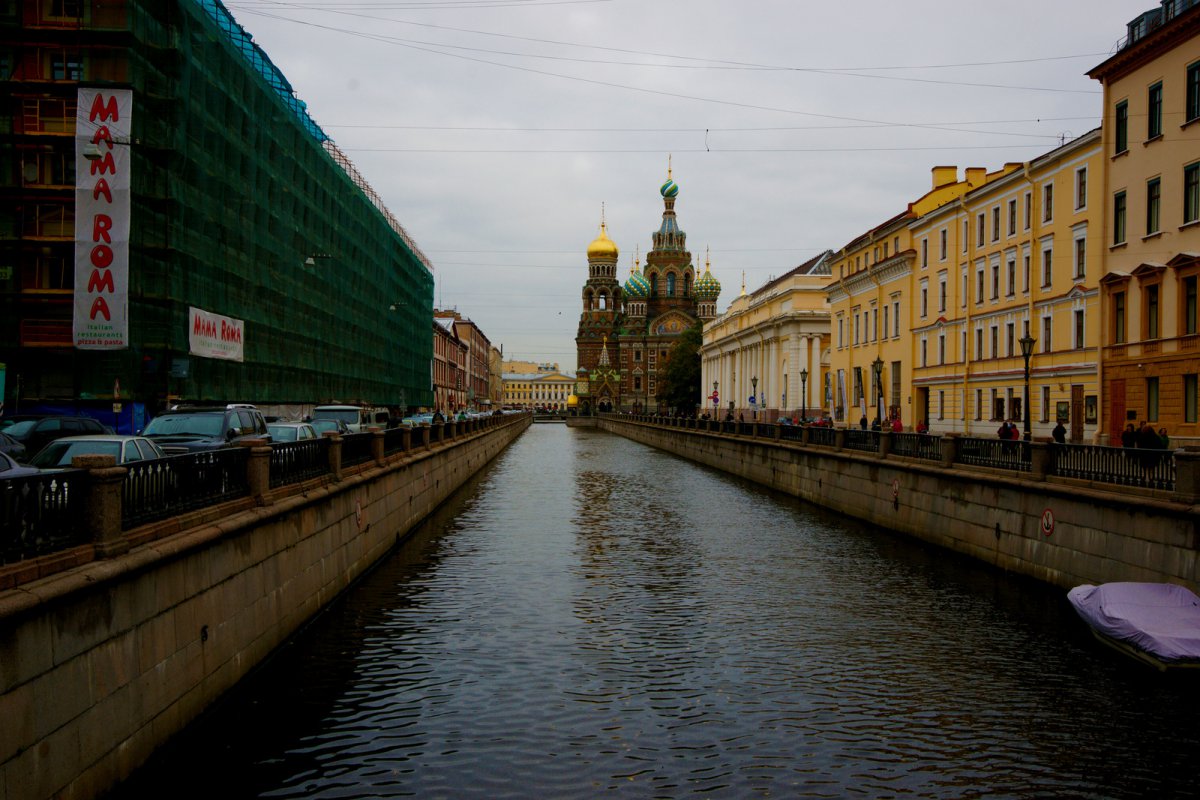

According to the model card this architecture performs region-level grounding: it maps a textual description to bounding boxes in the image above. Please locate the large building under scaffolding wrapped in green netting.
[0,0,433,427]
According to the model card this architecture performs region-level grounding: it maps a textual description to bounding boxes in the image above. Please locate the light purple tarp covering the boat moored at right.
[1067,583,1200,661]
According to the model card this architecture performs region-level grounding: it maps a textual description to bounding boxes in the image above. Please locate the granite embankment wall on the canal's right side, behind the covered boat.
[598,416,1200,590]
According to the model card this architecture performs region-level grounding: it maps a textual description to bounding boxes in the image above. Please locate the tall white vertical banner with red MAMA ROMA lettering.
[72,88,133,350]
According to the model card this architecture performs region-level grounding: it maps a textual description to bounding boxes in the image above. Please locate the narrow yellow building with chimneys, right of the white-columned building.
[826,164,1018,428]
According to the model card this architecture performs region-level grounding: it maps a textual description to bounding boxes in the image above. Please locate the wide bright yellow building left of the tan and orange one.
[902,130,1104,441]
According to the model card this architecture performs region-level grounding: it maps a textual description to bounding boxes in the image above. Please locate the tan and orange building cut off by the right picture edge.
[1088,0,1200,444]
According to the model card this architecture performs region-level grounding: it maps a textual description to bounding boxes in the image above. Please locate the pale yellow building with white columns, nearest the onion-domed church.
[700,251,832,421]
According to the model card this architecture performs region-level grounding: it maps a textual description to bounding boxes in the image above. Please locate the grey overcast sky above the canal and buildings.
[226,0,1156,371]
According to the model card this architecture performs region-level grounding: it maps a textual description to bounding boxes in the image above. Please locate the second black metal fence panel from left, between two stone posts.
[121,447,250,530]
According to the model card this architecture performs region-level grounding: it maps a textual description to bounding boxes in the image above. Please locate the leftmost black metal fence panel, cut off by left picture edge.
[0,470,88,564]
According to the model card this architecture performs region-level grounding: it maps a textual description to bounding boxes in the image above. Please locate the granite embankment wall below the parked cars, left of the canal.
[0,415,530,800]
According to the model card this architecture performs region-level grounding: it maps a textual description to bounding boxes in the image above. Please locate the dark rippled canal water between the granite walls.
[116,425,1200,799]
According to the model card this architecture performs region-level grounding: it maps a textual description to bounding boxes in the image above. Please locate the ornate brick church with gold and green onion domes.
[575,167,721,414]
